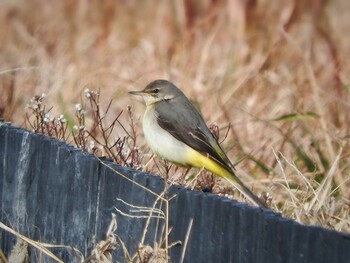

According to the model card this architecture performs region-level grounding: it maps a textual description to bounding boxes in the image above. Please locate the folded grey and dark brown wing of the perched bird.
[156,97,232,171]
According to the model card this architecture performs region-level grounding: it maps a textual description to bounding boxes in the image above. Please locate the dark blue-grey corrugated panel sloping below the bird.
[0,125,350,263]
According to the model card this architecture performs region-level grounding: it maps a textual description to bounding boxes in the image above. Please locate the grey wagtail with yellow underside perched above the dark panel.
[129,80,268,208]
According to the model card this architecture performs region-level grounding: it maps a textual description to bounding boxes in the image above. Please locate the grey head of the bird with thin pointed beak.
[129,79,184,105]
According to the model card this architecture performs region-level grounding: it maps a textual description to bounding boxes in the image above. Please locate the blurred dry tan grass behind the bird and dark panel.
[0,0,350,235]
